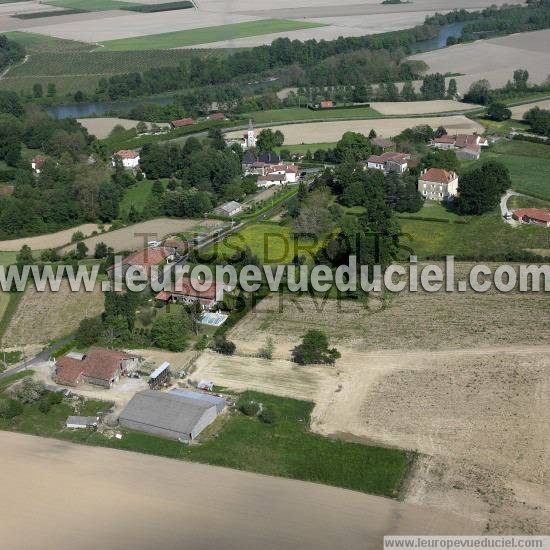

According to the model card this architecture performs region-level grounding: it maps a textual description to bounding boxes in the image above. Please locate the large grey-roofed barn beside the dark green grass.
[118,390,223,443]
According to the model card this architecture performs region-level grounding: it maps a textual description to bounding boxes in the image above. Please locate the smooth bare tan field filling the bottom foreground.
[0,432,473,550]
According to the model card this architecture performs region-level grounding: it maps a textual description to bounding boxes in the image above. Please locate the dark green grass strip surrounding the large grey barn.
[0,392,408,497]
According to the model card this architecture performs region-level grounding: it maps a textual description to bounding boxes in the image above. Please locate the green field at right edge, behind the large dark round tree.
[474,141,550,200]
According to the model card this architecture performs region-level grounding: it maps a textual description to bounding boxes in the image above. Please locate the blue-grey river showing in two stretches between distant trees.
[43,23,464,119]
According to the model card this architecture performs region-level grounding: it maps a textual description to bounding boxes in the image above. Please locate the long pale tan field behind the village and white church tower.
[228,115,484,145]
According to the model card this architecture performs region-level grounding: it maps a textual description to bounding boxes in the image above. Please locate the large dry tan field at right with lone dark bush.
[192,265,550,534]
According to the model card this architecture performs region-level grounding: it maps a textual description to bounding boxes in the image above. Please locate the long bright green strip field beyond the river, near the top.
[100,19,324,51]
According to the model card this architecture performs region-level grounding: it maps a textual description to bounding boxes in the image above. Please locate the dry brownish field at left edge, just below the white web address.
[3,281,103,346]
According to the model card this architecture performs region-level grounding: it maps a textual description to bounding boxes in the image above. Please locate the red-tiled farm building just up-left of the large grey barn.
[54,348,138,388]
